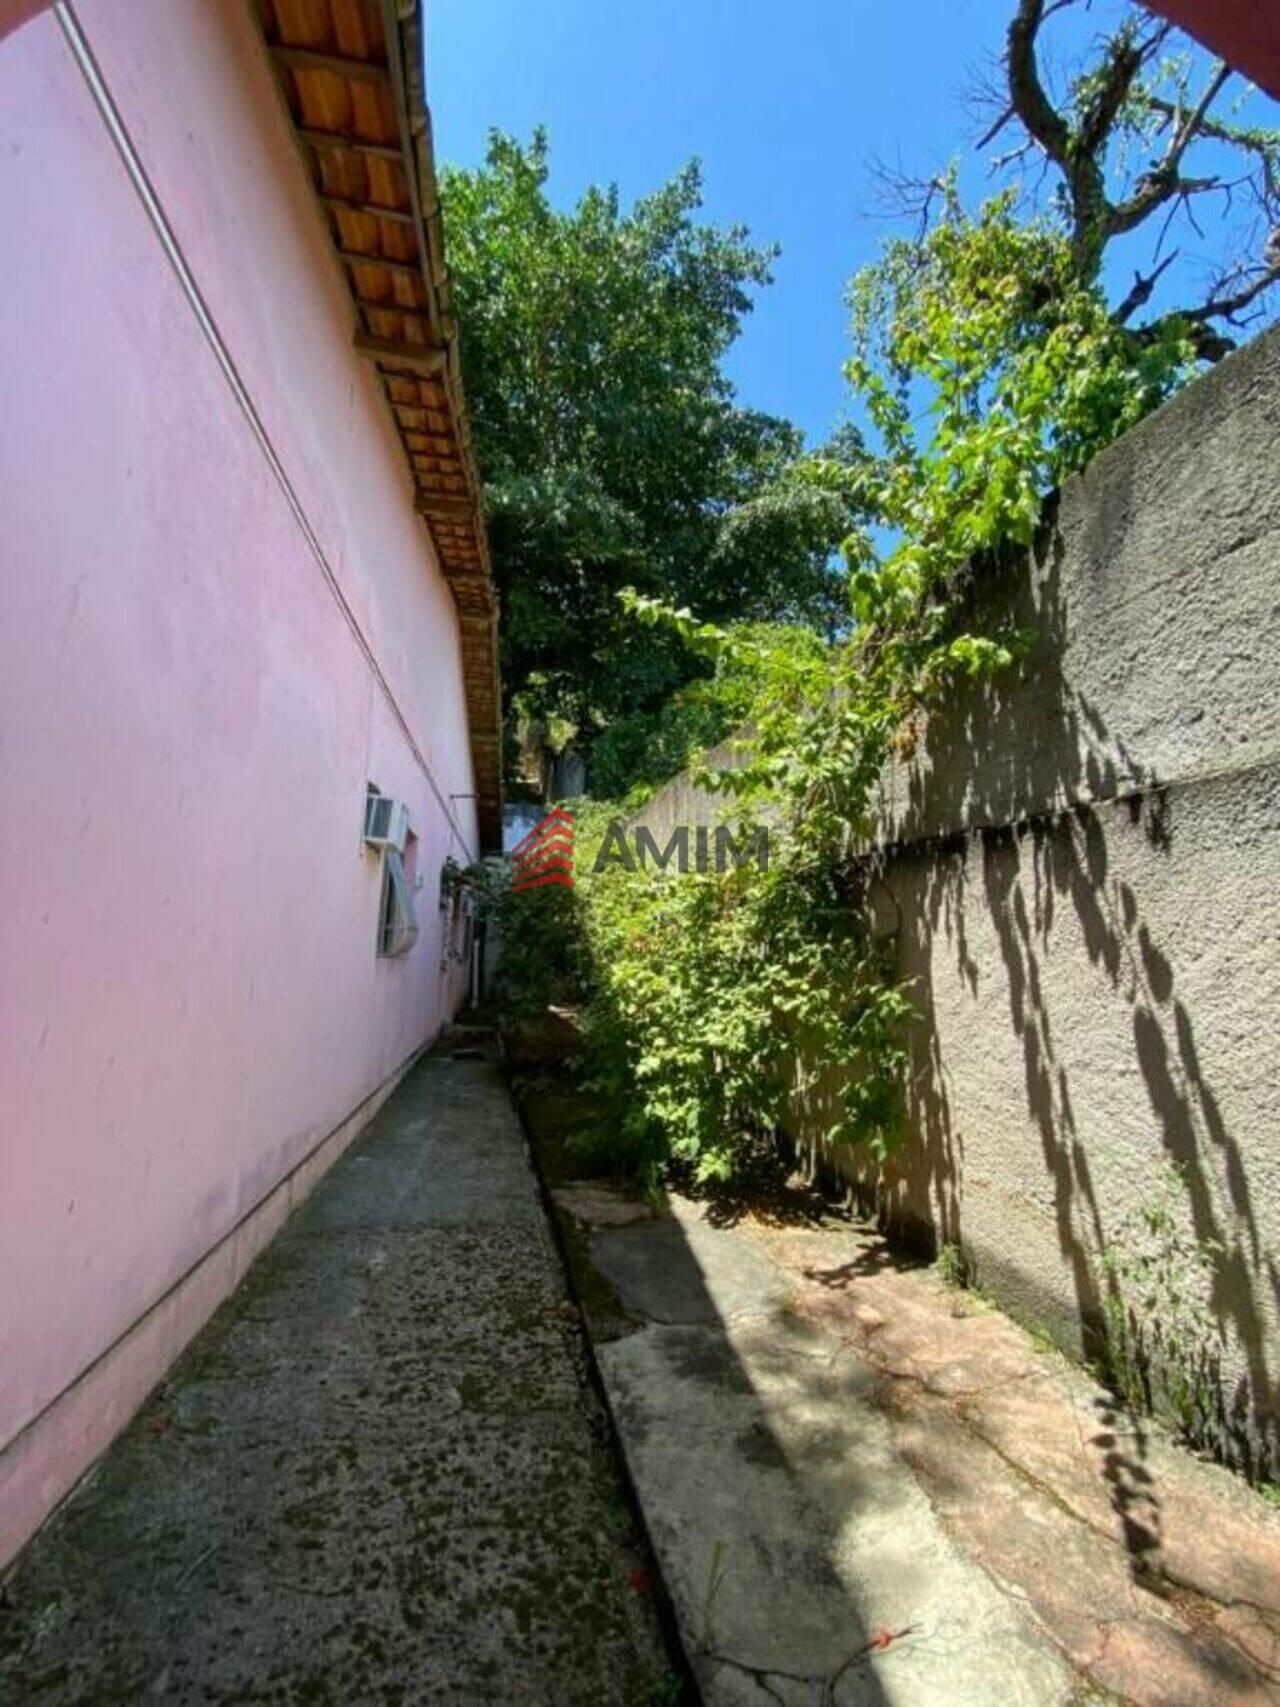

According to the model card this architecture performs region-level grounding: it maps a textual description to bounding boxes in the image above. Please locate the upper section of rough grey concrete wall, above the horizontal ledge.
[881,331,1280,843]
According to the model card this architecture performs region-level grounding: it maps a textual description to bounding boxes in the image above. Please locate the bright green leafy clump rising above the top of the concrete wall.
[847,178,1195,566]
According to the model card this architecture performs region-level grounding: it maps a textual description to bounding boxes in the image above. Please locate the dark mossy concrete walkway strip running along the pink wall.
[0,1050,679,1707]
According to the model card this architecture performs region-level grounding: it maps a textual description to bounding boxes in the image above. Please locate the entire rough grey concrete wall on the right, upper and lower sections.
[645,331,1280,1465]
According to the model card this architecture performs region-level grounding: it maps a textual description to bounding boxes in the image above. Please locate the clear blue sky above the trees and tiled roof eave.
[427,0,1280,440]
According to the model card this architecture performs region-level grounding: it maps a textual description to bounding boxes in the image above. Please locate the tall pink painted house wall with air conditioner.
[0,0,474,1558]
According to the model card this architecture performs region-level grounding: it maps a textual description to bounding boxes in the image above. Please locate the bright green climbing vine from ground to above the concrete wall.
[505,193,1195,1178]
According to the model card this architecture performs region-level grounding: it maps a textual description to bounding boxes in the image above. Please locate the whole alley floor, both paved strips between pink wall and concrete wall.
[0,1028,1280,1707]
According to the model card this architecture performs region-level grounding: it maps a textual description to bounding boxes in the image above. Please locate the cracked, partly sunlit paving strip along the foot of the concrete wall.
[555,1181,1280,1707]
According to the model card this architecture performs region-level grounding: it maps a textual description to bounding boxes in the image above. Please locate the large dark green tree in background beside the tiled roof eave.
[442,131,863,764]
